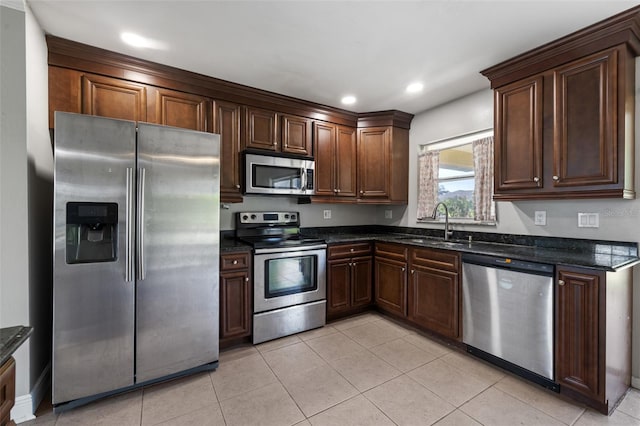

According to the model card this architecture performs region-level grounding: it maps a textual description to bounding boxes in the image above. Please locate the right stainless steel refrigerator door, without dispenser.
[136,123,220,383]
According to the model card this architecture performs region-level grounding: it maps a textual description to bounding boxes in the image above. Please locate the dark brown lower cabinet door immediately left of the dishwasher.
[408,265,459,339]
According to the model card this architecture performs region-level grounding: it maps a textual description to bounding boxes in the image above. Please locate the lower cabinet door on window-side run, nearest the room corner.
[375,257,407,316]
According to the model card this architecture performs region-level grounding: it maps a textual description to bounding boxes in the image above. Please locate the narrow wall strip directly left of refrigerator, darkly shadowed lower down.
[24,1,53,413]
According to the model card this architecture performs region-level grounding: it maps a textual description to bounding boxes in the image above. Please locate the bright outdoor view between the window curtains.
[438,143,475,219]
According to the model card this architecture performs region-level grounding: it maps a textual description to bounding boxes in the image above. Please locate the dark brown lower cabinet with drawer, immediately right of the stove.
[327,242,373,319]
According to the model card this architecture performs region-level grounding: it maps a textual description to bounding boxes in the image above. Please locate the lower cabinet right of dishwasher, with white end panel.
[555,266,632,413]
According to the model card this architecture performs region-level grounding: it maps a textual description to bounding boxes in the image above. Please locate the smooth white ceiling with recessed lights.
[26,0,639,113]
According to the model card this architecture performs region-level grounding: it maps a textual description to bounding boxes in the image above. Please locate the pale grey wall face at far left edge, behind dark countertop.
[0,0,30,404]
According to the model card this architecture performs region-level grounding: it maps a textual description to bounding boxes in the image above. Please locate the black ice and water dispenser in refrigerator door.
[66,202,118,263]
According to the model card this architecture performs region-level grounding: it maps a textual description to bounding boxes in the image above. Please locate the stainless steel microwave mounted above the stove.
[244,153,315,195]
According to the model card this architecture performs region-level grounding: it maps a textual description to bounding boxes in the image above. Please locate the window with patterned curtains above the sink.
[417,130,495,224]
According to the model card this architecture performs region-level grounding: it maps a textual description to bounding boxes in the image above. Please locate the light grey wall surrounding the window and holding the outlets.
[402,68,640,387]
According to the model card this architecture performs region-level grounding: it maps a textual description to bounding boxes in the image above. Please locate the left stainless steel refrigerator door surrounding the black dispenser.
[52,112,136,404]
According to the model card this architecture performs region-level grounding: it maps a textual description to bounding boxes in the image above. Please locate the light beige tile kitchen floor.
[23,313,640,426]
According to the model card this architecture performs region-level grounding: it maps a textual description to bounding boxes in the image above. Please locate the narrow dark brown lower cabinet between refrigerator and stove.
[220,252,253,346]
